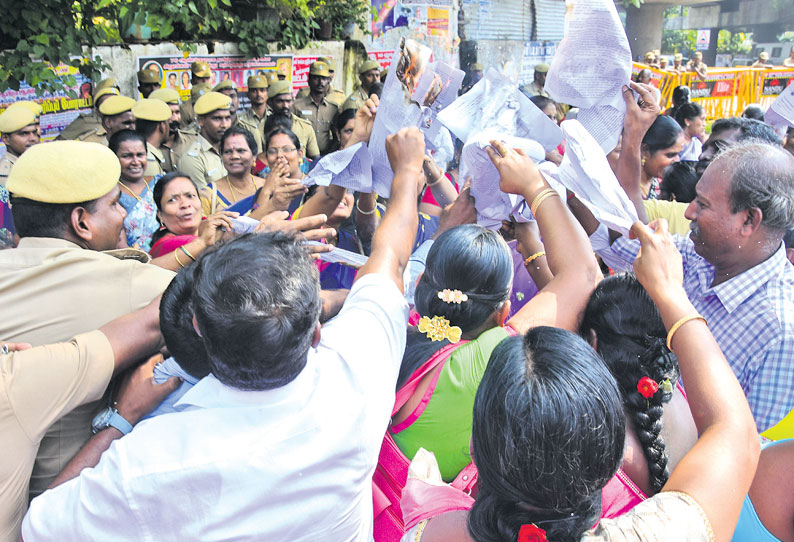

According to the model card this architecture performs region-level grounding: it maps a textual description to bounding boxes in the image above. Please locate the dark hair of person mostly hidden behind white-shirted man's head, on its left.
[160,265,210,378]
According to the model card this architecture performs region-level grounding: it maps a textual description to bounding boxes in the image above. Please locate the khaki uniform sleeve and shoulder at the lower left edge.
[0,331,114,540]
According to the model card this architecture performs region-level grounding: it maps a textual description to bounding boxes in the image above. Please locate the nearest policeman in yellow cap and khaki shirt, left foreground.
[0,141,174,502]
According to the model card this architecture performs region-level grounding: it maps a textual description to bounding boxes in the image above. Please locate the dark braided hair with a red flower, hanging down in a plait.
[579,274,679,493]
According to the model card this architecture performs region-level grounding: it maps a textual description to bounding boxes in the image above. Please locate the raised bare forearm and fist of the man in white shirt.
[356,125,425,292]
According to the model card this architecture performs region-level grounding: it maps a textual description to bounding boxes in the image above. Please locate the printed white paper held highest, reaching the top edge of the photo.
[544,0,631,153]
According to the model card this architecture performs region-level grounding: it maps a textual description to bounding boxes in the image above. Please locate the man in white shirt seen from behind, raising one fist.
[22,104,424,541]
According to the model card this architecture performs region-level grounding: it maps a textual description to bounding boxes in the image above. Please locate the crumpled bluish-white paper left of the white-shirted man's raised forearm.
[303,142,372,193]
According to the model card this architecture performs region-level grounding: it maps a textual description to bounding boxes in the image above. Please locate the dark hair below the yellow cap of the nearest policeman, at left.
[11,194,97,238]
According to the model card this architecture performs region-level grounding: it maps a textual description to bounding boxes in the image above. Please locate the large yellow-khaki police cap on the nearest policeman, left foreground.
[6,141,121,203]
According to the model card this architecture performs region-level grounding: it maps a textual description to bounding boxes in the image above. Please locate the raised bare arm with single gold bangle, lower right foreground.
[632,220,760,541]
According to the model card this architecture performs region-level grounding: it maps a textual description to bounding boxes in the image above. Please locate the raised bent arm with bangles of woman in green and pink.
[487,141,601,333]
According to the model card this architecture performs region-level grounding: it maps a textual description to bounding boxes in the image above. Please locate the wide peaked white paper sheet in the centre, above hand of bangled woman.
[438,68,562,151]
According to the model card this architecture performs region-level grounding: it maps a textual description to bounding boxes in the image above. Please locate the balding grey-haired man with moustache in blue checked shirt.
[606,142,794,432]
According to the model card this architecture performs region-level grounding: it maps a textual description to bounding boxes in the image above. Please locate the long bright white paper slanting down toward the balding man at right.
[558,120,638,235]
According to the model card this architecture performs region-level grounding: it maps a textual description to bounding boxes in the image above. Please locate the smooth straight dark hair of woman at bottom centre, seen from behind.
[468,327,626,542]
